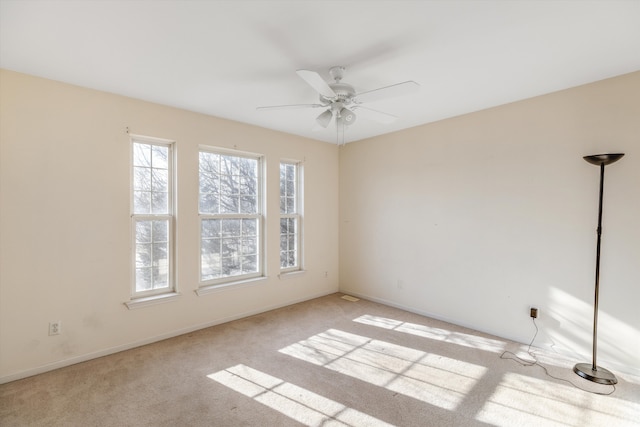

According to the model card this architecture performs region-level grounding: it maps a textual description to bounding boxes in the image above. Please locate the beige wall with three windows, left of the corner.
[0,70,338,381]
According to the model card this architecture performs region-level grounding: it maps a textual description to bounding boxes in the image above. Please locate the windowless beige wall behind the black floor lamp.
[340,72,640,374]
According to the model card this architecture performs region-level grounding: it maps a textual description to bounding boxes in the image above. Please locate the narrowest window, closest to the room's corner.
[280,162,301,271]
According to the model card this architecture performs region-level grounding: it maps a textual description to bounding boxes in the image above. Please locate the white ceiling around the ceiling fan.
[0,0,640,143]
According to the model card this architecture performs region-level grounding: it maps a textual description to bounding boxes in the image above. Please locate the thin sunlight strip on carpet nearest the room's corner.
[353,314,505,353]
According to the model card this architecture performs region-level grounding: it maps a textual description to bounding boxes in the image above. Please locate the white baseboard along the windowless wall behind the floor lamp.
[340,288,640,380]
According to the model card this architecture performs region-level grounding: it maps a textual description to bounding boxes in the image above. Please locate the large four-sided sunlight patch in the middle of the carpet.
[279,329,486,410]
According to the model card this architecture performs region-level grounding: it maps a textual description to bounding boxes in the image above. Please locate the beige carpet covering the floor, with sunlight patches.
[0,294,640,427]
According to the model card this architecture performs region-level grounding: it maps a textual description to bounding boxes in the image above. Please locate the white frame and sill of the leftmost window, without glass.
[126,135,178,302]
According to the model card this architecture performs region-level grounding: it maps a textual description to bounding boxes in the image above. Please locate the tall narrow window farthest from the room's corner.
[131,138,174,298]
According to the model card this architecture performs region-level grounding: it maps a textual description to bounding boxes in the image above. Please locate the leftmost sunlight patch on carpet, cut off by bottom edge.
[207,364,391,427]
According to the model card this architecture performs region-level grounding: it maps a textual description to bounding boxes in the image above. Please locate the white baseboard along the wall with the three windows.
[0,290,337,384]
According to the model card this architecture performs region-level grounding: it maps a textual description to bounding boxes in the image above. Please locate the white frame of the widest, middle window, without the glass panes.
[196,146,265,295]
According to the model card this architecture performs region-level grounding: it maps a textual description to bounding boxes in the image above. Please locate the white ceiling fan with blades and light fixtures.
[257,66,420,144]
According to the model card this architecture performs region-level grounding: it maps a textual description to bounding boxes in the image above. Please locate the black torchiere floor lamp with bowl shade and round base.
[573,153,624,384]
